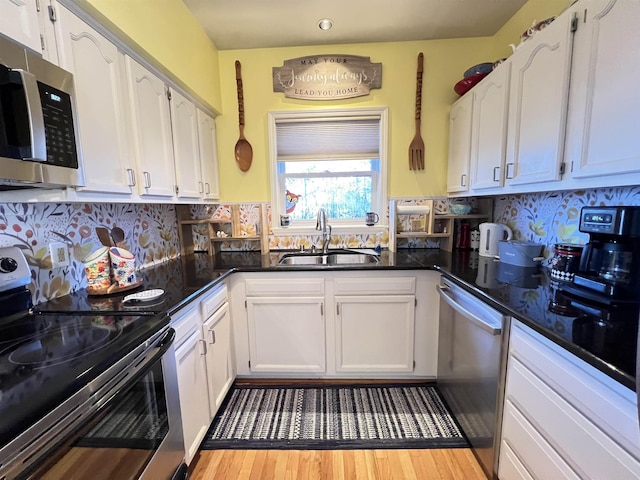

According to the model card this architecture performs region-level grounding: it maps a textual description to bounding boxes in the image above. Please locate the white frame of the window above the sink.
[268,107,389,235]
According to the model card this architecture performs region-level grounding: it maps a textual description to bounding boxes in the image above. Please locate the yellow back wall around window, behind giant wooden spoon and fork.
[216,38,494,202]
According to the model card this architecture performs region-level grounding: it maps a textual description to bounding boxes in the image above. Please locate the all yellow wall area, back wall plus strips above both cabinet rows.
[85,0,568,202]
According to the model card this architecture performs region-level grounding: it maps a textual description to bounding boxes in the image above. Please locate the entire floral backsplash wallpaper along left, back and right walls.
[0,186,640,303]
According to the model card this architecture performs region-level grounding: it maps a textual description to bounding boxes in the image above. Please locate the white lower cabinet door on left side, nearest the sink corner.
[202,302,235,418]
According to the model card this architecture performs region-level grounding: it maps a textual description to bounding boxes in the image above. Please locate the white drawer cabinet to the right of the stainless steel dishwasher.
[498,322,640,480]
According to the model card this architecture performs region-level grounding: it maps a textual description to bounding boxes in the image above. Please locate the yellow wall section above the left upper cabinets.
[86,0,221,112]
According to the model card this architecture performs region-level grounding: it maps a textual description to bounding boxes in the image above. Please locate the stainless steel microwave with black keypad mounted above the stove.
[0,36,84,190]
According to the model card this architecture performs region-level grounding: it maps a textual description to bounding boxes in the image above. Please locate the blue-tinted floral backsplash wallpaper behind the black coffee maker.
[494,185,640,258]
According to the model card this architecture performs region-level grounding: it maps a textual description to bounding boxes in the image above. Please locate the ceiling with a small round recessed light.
[183,0,526,50]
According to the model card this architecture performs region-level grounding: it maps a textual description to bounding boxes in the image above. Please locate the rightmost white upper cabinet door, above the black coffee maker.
[567,0,640,180]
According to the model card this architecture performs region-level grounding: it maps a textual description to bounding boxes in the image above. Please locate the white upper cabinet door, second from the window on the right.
[471,62,511,190]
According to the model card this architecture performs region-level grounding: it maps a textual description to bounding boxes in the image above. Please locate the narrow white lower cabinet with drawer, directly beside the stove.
[171,303,210,465]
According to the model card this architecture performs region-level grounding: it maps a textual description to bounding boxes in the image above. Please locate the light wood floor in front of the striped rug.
[190,448,487,480]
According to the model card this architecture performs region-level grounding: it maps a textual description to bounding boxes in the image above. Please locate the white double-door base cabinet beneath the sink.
[230,271,438,378]
